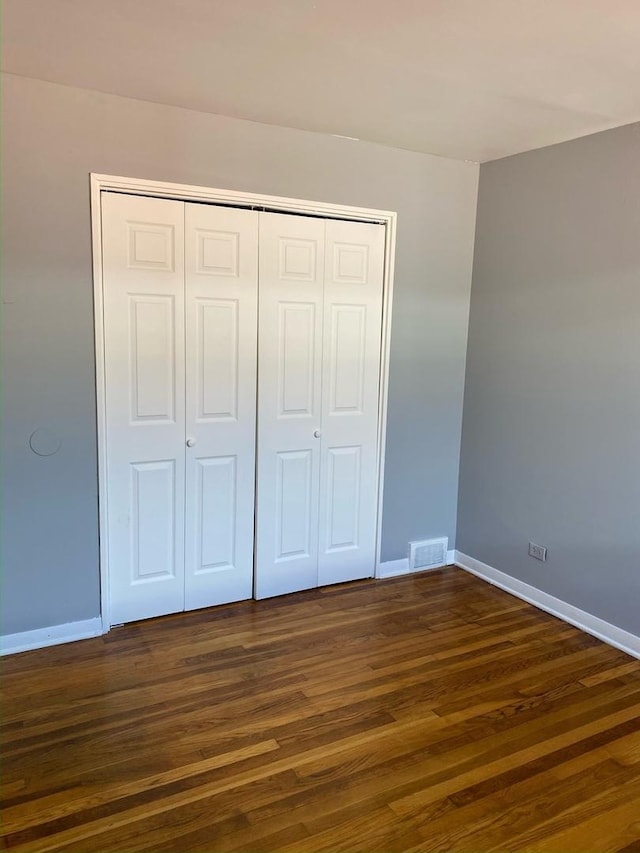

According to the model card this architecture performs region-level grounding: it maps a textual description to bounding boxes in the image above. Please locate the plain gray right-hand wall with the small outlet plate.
[458,125,640,634]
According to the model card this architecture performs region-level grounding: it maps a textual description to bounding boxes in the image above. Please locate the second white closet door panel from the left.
[185,204,258,610]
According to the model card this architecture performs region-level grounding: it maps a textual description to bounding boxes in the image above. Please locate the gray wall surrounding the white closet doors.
[2,75,478,633]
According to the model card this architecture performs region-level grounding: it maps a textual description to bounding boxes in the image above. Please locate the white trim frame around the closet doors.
[90,173,397,633]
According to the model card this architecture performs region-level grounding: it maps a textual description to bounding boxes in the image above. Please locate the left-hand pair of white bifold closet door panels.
[102,193,258,624]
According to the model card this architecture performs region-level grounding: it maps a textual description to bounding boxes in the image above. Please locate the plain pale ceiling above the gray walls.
[3,0,640,162]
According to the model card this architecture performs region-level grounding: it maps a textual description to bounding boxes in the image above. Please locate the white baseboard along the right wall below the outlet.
[454,551,640,658]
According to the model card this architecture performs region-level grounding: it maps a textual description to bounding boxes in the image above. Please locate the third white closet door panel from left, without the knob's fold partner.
[255,213,324,598]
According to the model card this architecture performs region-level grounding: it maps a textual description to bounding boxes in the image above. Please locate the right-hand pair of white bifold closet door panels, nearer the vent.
[255,213,384,598]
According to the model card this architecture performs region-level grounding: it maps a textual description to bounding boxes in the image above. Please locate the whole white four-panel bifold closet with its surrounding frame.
[91,175,396,631]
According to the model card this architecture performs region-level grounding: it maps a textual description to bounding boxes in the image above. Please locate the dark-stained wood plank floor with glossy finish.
[2,568,640,853]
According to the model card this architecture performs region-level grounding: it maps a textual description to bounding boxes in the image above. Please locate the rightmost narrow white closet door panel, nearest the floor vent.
[318,220,384,586]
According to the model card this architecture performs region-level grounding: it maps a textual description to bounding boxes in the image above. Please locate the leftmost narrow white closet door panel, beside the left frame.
[102,193,185,623]
